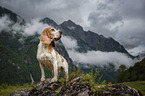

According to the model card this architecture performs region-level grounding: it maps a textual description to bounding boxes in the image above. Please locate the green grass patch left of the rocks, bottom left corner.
[0,84,33,96]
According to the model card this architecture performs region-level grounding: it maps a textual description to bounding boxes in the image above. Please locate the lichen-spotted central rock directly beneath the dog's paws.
[29,76,92,96]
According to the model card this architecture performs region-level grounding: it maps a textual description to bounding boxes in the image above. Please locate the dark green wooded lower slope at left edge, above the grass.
[0,45,30,84]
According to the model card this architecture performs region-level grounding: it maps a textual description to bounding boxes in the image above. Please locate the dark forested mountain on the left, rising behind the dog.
[0,7,74,85]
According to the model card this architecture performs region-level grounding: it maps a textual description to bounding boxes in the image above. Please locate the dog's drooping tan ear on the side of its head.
[40,30,51,44]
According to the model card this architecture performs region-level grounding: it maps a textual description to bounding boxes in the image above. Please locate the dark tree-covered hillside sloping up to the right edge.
[117,58,145,82]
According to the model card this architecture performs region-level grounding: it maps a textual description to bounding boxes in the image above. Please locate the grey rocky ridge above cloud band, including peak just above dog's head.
[41,17,134,58]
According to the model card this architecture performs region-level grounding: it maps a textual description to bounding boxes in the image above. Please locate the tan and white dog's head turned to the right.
[40,27,62,47]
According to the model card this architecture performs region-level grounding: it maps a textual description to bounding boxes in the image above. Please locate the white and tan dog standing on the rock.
[37,27,68,82]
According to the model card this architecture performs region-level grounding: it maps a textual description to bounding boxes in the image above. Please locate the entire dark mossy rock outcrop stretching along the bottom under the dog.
[9,76,143,96]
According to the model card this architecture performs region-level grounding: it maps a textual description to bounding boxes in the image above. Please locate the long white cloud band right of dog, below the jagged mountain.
[62,36,134,69]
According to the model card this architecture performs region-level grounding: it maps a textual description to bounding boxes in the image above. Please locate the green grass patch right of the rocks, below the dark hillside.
[121,81,145,95]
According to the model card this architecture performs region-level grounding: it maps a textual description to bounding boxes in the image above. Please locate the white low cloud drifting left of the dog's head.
[0,15,49,36]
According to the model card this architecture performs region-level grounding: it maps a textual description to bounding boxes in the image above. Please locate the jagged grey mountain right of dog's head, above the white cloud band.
[60,20,131,56]
